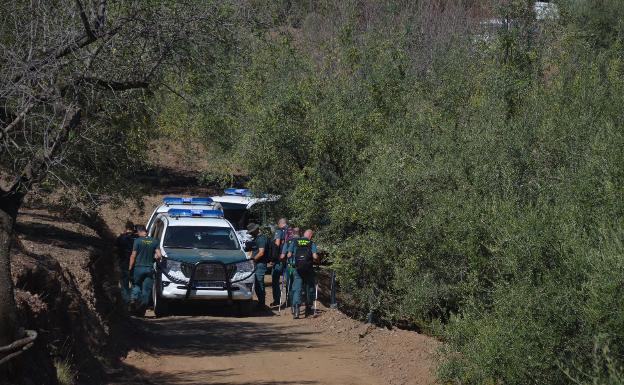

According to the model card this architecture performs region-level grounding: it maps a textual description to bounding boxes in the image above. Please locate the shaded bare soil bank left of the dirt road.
[8,208,125,385]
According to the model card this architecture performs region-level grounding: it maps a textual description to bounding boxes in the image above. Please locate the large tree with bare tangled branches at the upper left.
[0,0,228,345]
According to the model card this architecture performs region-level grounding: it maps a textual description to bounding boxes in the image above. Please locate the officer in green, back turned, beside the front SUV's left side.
[128,226,162,311]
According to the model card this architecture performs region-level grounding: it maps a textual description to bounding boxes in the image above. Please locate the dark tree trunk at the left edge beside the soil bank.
[0,195,21,346]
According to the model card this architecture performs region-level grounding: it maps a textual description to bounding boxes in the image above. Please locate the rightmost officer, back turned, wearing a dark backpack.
[288,229,319,319]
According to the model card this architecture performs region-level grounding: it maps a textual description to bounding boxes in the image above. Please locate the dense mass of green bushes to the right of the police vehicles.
[151,0,624,384]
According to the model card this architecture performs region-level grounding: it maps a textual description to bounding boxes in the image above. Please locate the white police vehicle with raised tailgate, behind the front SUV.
[210,188,280,244]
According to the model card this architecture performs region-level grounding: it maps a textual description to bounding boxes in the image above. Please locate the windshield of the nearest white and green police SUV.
[163,226,240,250]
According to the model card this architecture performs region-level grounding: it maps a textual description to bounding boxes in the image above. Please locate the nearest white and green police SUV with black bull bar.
[150,198,254,317]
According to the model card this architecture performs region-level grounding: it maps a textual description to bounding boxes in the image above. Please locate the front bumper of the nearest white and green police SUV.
[156,262,254,301]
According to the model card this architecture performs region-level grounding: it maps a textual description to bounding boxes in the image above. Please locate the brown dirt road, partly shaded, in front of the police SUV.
[110,288,436,385]
